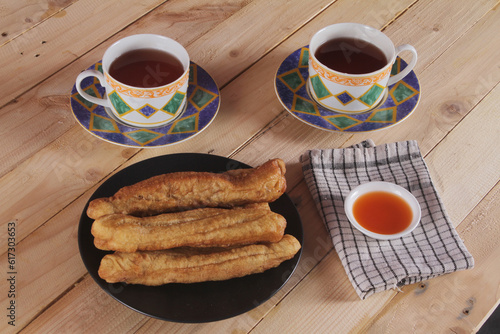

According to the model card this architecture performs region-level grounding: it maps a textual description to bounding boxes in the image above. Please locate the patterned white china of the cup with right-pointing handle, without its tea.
[307,23,417,114]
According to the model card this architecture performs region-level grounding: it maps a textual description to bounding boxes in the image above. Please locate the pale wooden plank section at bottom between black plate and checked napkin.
[252,235,395,333]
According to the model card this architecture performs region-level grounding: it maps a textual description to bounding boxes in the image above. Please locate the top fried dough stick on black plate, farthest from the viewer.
[87,159,286,219]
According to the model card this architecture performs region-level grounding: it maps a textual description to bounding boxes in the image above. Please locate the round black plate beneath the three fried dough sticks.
[78,153,303,323]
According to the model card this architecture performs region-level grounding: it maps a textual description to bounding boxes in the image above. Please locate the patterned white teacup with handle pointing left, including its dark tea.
[76,34,190,127]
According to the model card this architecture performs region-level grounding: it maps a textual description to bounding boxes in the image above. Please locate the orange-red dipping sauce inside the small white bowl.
[352,191,413,234]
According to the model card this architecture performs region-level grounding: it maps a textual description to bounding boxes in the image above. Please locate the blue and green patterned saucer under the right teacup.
[275,46,420,132]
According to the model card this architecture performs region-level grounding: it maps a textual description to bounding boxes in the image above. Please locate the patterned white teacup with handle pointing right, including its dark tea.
[307,23,417,114]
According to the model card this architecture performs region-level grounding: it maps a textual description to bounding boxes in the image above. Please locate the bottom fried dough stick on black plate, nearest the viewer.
[98,234,301,286]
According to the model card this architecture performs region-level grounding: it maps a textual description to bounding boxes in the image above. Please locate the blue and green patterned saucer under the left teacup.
[71,62,220,148]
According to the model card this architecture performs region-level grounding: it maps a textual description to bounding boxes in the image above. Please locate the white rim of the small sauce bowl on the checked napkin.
[344,181,422,240]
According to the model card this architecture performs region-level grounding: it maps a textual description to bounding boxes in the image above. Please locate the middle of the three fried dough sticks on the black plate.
[91,205,286,252]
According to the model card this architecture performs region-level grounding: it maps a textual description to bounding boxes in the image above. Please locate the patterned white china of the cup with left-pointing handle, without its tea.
[76,34,190,127]
